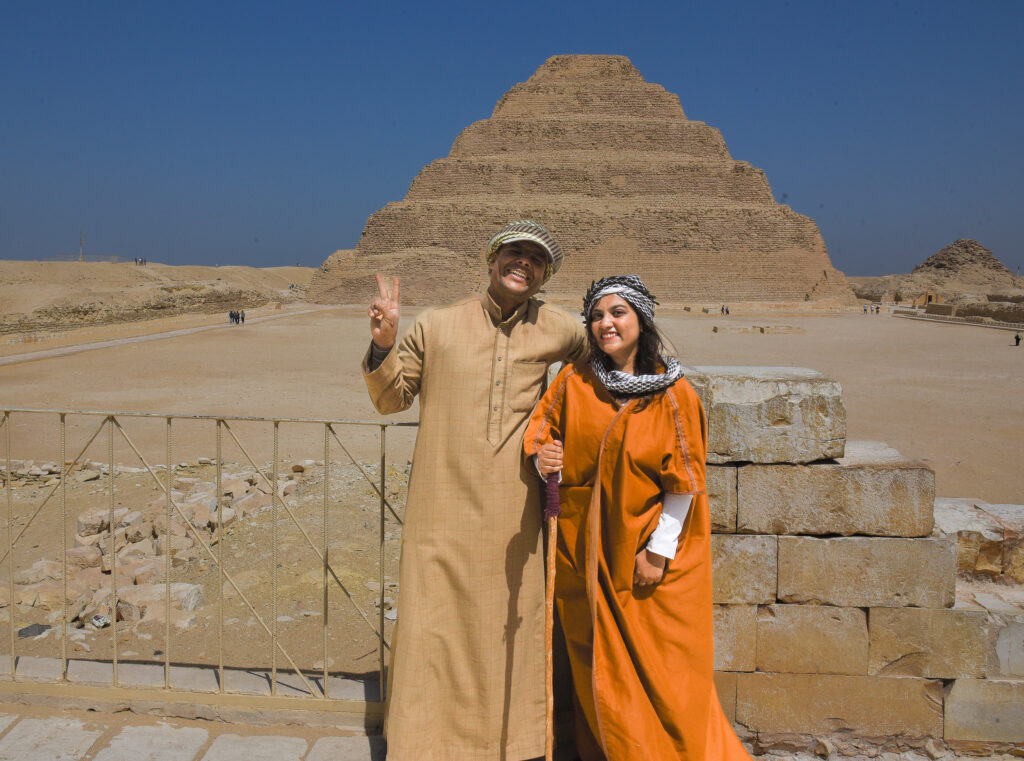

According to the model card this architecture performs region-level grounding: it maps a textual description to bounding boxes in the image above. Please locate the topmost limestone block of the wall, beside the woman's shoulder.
[686,366,846,464]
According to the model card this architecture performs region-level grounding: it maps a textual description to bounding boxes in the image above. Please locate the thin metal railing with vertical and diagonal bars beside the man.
[0,409,416,702]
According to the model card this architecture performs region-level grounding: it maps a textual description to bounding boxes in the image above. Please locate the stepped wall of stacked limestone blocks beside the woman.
[704,367,1024,758]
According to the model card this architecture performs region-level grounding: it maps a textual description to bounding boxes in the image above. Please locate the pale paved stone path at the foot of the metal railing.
[0,704,384,761]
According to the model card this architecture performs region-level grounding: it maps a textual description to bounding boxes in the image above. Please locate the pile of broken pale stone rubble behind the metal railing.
[0,458,315,629]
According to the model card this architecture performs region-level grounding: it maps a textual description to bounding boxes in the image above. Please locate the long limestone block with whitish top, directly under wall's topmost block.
[736,441,935,537]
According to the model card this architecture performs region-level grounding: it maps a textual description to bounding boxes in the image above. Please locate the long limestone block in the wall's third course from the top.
[778,537,956,607]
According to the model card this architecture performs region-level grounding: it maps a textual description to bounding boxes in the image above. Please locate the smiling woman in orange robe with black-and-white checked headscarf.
[524,276,750,761]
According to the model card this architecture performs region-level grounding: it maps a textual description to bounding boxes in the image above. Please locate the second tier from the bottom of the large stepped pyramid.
[406,152,775,203]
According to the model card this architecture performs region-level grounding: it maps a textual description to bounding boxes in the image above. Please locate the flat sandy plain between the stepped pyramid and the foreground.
[0,306,1024,504]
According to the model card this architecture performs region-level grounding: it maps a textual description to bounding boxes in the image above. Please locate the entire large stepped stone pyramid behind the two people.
[308,55,855,304]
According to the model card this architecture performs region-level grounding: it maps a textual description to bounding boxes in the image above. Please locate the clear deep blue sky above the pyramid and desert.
[0,0,1024,274]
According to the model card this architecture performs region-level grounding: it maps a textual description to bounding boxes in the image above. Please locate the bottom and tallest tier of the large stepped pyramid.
[342,197,849,304]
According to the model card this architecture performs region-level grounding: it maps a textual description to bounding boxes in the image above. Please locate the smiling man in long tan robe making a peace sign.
[362,220,587,761]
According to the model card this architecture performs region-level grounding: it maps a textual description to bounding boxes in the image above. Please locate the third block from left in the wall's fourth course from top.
[868,607,989,679]
